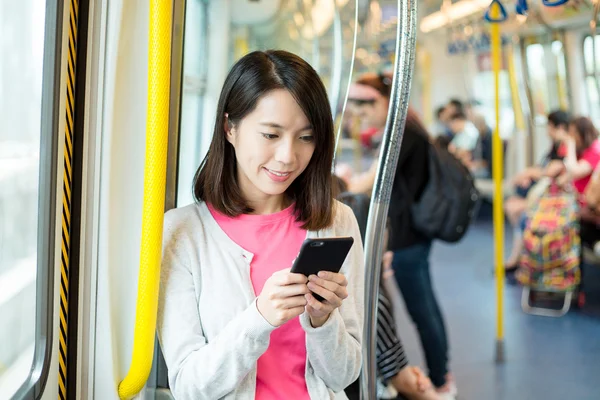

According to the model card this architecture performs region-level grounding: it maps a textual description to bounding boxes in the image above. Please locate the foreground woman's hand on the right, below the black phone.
[305,271,348,328]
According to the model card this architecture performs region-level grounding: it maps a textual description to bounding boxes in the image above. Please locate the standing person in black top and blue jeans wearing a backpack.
[348,74,456,399]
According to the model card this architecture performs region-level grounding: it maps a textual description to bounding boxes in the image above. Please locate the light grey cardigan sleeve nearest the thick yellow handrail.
[157,213,274,400]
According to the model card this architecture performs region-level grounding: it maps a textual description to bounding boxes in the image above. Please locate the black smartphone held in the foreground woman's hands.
[291,237,354,301]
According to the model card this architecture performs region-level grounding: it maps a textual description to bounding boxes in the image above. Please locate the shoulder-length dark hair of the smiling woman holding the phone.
[194,50,335,230]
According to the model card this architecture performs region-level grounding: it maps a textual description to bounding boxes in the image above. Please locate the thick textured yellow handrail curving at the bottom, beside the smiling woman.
[119,0,173,399]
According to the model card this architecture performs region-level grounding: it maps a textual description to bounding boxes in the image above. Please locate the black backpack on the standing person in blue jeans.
[411,145,480,243]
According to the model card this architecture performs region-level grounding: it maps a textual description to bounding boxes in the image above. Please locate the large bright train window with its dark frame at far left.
[0,0,60,399]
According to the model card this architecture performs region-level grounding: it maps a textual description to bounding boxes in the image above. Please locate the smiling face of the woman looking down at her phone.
[225,89,315,208]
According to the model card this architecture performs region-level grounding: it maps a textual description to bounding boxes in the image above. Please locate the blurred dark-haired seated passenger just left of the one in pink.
[504,110,571,273]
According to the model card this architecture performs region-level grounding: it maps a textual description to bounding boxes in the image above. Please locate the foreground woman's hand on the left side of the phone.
[256,268,309,327]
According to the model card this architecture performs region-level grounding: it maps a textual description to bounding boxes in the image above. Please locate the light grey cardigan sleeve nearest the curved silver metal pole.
[300,203,364,392]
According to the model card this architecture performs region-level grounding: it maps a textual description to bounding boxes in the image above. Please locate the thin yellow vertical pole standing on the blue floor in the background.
[491,3,504,362]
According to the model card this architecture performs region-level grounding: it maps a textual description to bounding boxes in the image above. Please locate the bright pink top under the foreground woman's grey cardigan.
[208,204,310,400]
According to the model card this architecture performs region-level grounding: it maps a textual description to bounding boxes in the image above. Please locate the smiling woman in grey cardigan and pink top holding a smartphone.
[158,51,364,400]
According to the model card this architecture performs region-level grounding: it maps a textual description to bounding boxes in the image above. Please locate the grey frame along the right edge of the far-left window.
[13,0,64,399]
